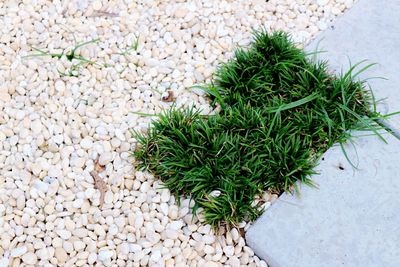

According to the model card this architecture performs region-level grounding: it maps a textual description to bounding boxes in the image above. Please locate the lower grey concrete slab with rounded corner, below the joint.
[246,136,400,267]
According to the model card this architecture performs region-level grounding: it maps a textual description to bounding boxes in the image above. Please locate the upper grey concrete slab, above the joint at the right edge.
[307,0,400,131]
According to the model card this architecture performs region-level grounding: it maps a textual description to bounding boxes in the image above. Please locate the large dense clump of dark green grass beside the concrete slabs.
[133,31,390,227]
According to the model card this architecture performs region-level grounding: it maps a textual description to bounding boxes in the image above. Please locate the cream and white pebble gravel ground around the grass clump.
[0,0,353,267]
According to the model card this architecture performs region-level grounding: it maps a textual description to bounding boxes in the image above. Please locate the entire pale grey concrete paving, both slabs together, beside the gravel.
[246,0,400,267]
